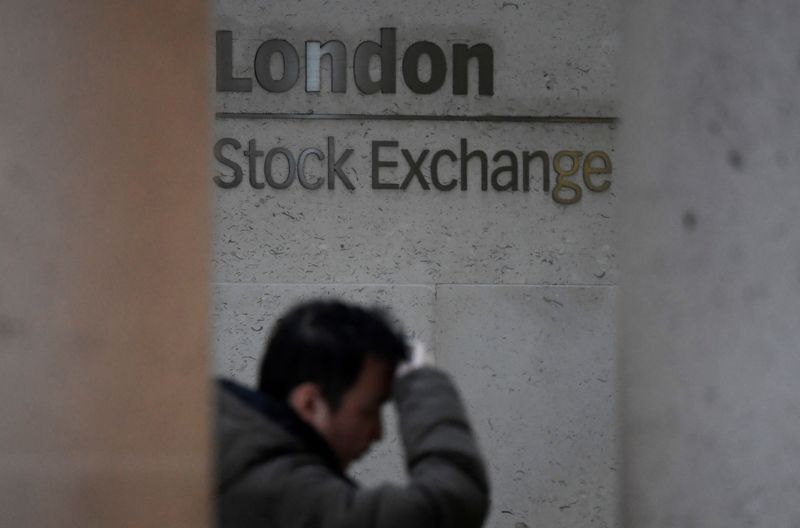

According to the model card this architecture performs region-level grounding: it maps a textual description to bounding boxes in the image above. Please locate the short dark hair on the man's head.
[258,300,408,410]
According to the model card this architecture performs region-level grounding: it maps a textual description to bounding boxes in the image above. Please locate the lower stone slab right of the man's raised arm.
[436,286,617,528]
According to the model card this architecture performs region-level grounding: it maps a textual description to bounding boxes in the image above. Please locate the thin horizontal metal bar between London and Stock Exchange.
[216,112,619,125]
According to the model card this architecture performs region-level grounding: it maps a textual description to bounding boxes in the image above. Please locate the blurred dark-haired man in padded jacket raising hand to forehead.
[217,301,488,528]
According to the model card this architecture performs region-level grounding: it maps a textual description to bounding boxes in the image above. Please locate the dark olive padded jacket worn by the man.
[217,368,488,528]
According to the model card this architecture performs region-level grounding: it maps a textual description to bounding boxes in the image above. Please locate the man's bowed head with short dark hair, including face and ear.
[259,301,408,467]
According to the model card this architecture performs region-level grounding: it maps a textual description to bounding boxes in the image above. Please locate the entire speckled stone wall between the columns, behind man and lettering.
[211,0,618,528]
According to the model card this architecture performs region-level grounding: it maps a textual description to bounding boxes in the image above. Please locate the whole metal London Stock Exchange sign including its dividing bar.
[213,27,614,205]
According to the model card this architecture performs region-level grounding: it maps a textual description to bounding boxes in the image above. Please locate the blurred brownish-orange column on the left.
[0,0,209,528]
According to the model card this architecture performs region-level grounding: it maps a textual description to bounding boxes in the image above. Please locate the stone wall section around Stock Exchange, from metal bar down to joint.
[214,121,617,284]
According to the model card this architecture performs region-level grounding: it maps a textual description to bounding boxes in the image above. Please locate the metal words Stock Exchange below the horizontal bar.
[214,137,612,205]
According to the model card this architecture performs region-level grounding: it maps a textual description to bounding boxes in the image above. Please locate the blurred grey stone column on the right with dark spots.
[619,0,800,528]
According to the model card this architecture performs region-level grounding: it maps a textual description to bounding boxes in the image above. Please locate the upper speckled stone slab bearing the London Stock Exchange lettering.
[212,1,617,284]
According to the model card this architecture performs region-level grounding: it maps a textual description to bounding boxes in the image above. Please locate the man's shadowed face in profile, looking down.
[318,356,394,468]
